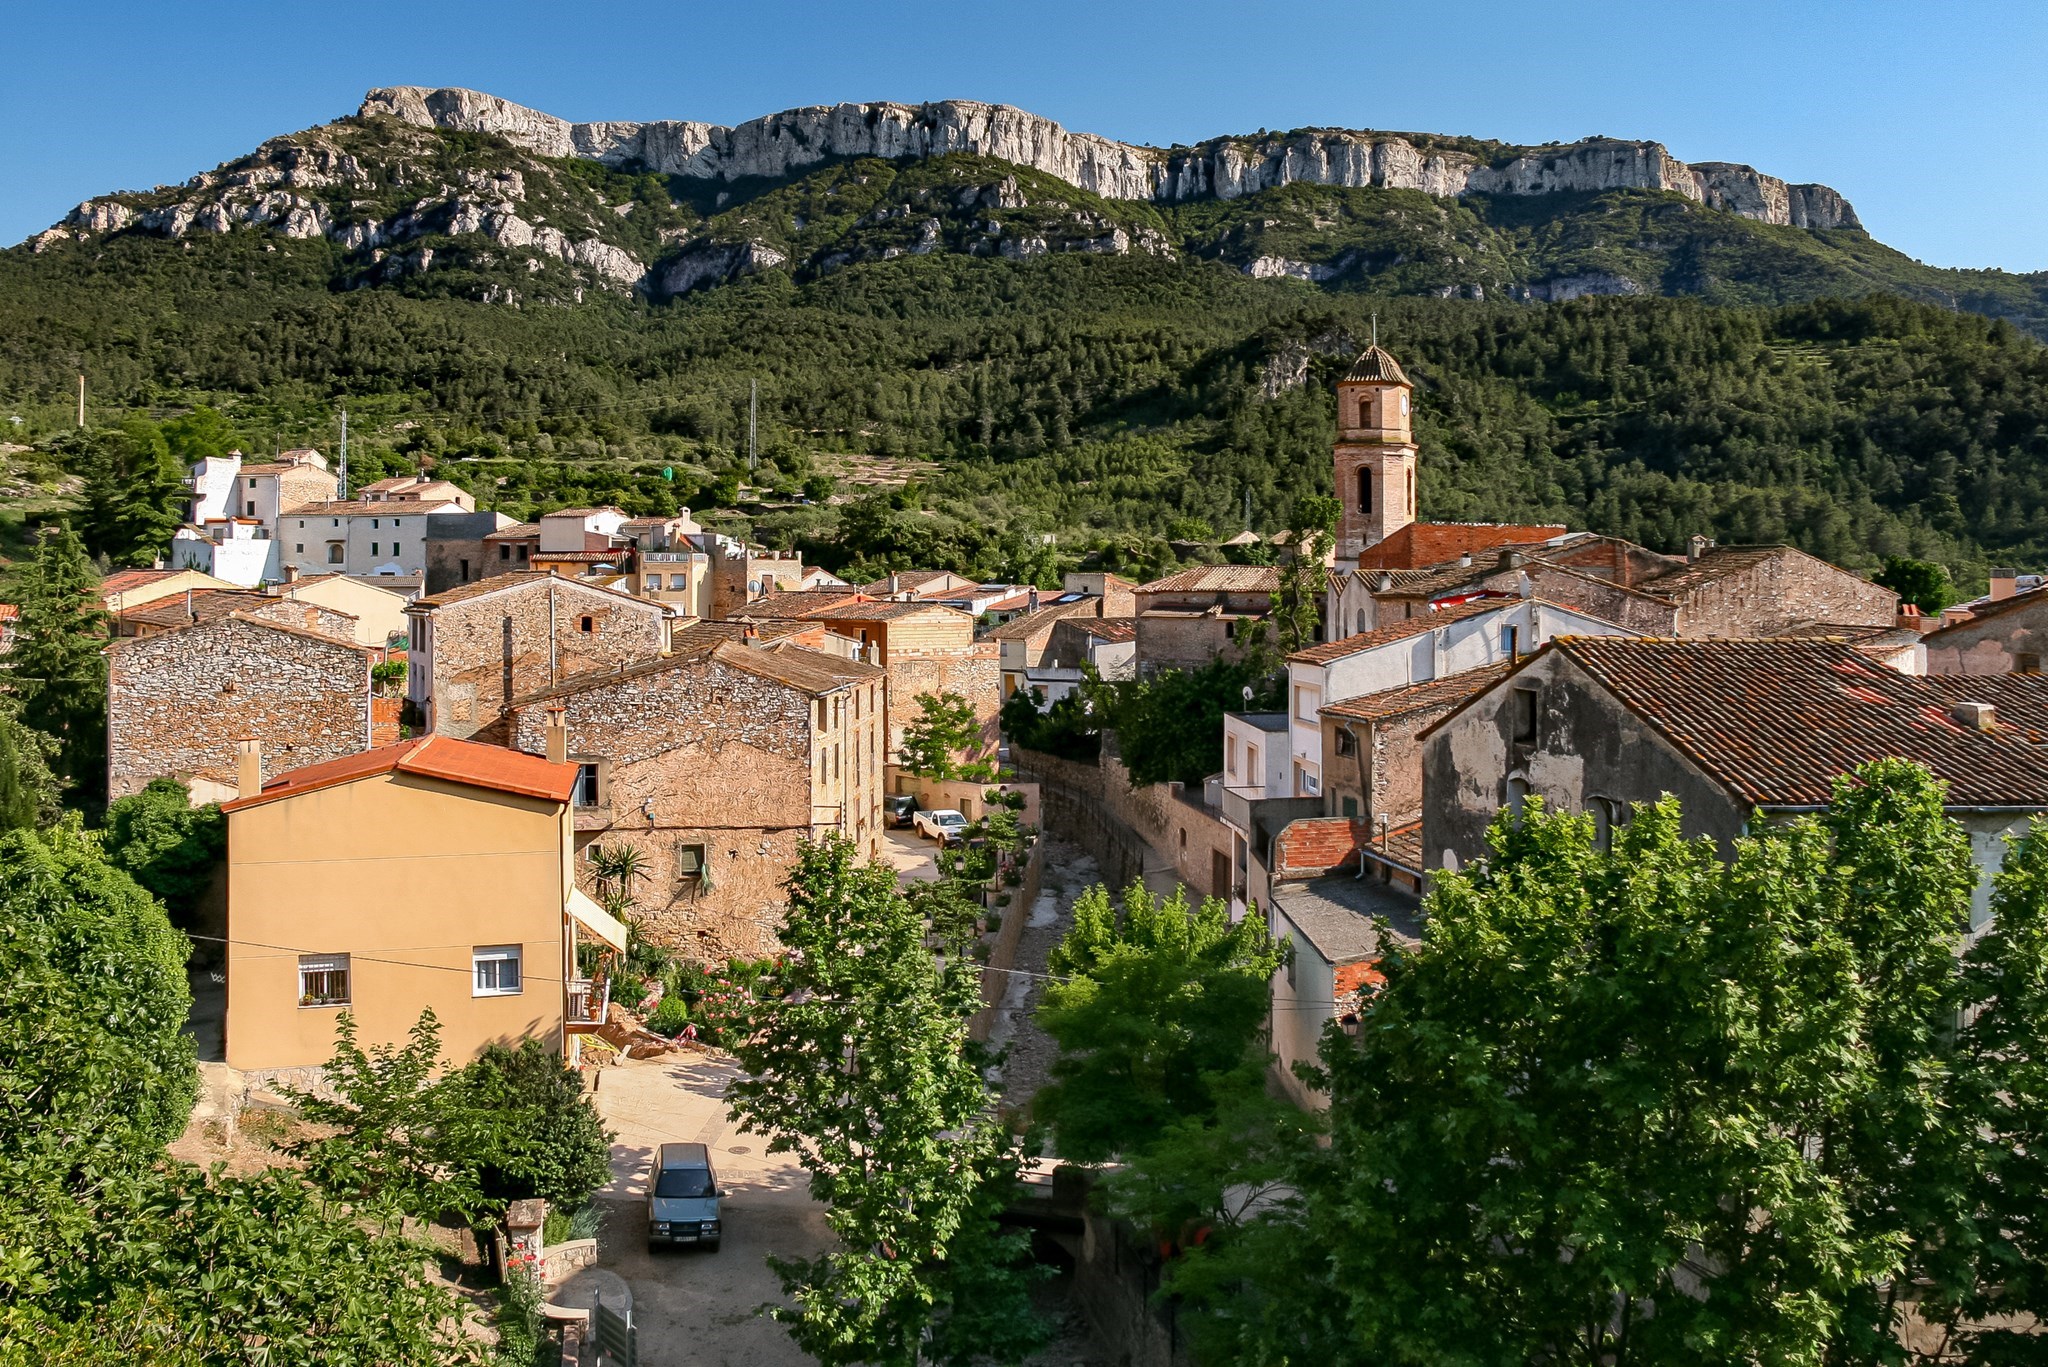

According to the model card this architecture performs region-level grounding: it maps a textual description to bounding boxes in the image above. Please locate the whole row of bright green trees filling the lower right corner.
[1040,760,2048,1367]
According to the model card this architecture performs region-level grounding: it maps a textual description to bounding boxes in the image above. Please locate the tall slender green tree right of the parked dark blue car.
[727,836,1040,1365]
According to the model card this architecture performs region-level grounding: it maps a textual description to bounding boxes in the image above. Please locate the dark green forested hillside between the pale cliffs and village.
[0,112,2048,582]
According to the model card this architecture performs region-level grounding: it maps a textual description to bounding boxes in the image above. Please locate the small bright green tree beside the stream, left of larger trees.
[1036,883,1282,1162]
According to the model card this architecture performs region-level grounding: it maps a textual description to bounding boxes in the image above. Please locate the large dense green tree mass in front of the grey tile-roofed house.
[1184,760,1980,1365]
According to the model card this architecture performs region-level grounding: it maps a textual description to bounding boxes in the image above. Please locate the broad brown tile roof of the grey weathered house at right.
[1552,635,2048,807]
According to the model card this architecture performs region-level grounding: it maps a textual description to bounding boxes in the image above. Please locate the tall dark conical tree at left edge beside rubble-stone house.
[6,527,106,803]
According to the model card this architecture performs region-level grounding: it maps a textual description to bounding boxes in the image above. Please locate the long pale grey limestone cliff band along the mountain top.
[360,86,1862,230]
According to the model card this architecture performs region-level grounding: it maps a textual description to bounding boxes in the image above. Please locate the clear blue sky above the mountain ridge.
[0,0,2048,271]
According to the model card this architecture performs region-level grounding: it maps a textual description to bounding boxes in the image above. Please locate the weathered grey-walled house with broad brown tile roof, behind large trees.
[1421,637,2048,926]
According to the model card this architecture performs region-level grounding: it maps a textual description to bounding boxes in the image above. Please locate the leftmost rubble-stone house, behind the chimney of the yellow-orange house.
[104,618,376,803]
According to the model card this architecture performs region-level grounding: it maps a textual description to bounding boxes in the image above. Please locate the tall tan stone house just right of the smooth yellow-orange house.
[512,639,887,959]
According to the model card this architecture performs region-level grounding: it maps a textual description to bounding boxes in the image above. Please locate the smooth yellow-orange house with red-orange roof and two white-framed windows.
[221,736,627,1084]
